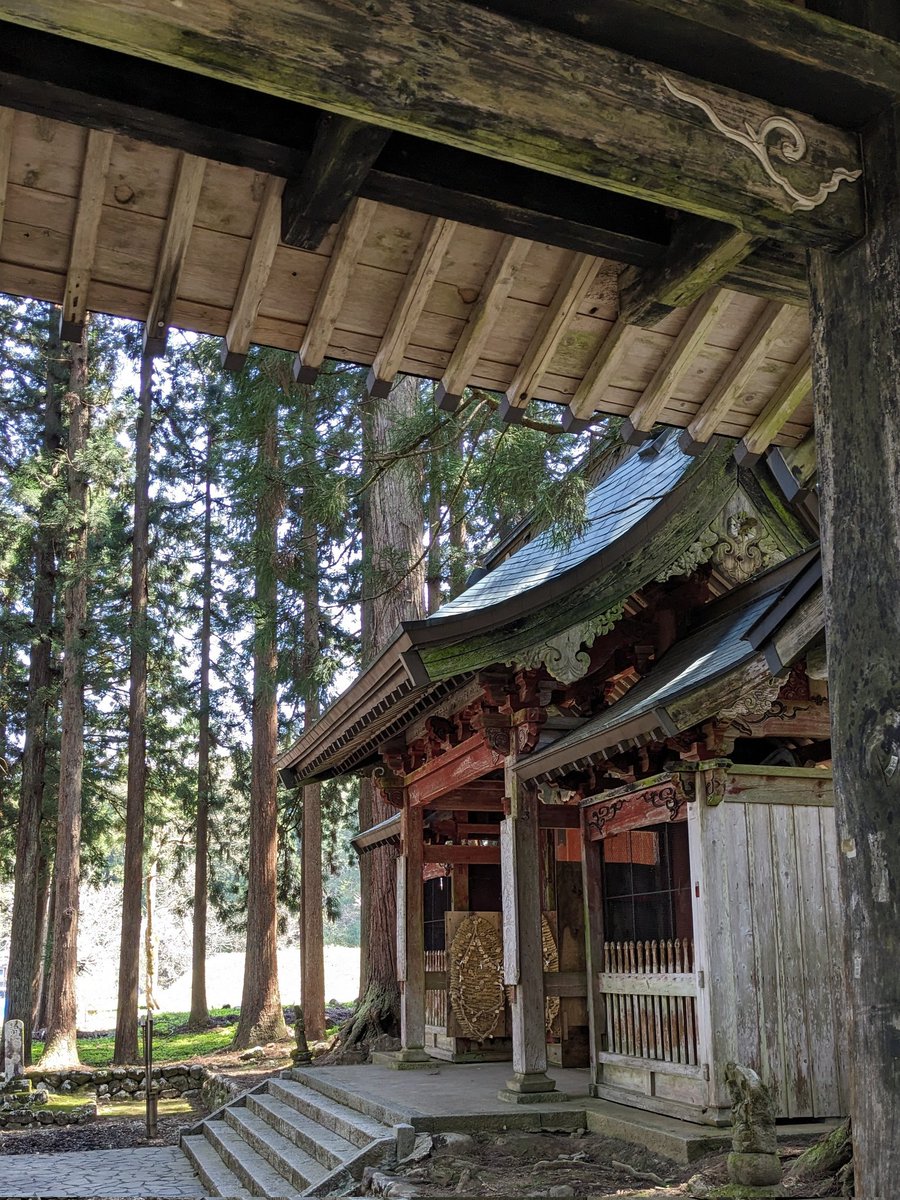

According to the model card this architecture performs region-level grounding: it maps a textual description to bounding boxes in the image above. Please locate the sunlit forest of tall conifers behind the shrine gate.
[0,296,613,1061]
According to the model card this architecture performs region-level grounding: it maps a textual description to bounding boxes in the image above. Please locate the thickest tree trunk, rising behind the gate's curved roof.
[342,376,425,1046]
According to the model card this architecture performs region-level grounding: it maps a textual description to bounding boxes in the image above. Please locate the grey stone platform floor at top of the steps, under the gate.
[295,1060,836,1163]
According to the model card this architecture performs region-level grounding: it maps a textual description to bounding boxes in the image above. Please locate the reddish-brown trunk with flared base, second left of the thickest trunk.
[234,379,288,1048]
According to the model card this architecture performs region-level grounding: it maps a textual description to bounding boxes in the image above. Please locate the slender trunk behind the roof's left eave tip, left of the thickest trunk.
[300,395,325,1042]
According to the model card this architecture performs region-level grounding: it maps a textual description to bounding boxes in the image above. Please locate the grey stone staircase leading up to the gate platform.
[181,1072,405,1200]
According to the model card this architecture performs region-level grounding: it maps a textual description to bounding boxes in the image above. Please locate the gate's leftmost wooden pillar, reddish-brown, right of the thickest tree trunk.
[396,802,431,1068]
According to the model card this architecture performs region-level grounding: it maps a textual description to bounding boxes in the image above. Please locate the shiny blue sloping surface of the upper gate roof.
[426,430,702,626]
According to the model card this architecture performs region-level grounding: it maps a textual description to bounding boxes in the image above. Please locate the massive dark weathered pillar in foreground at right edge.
[810,108,900,1200]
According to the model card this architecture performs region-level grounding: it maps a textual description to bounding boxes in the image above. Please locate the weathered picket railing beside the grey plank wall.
[600,937,697,1067]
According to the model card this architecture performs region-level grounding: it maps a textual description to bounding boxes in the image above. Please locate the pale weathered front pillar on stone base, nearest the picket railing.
[498,755,565,1104]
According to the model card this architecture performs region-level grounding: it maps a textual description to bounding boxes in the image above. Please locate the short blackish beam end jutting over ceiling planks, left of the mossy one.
[281,113,390,250]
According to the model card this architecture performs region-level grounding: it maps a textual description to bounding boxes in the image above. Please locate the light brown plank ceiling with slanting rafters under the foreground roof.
[0,109,812,452]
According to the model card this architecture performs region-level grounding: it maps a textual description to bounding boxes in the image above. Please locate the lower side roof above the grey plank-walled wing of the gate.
[517,550,822,779]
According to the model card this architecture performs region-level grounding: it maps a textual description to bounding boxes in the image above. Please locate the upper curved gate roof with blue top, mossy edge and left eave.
[278,430,811,786]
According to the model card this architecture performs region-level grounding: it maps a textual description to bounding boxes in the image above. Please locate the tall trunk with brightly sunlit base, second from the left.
[39,322,90,1067]
